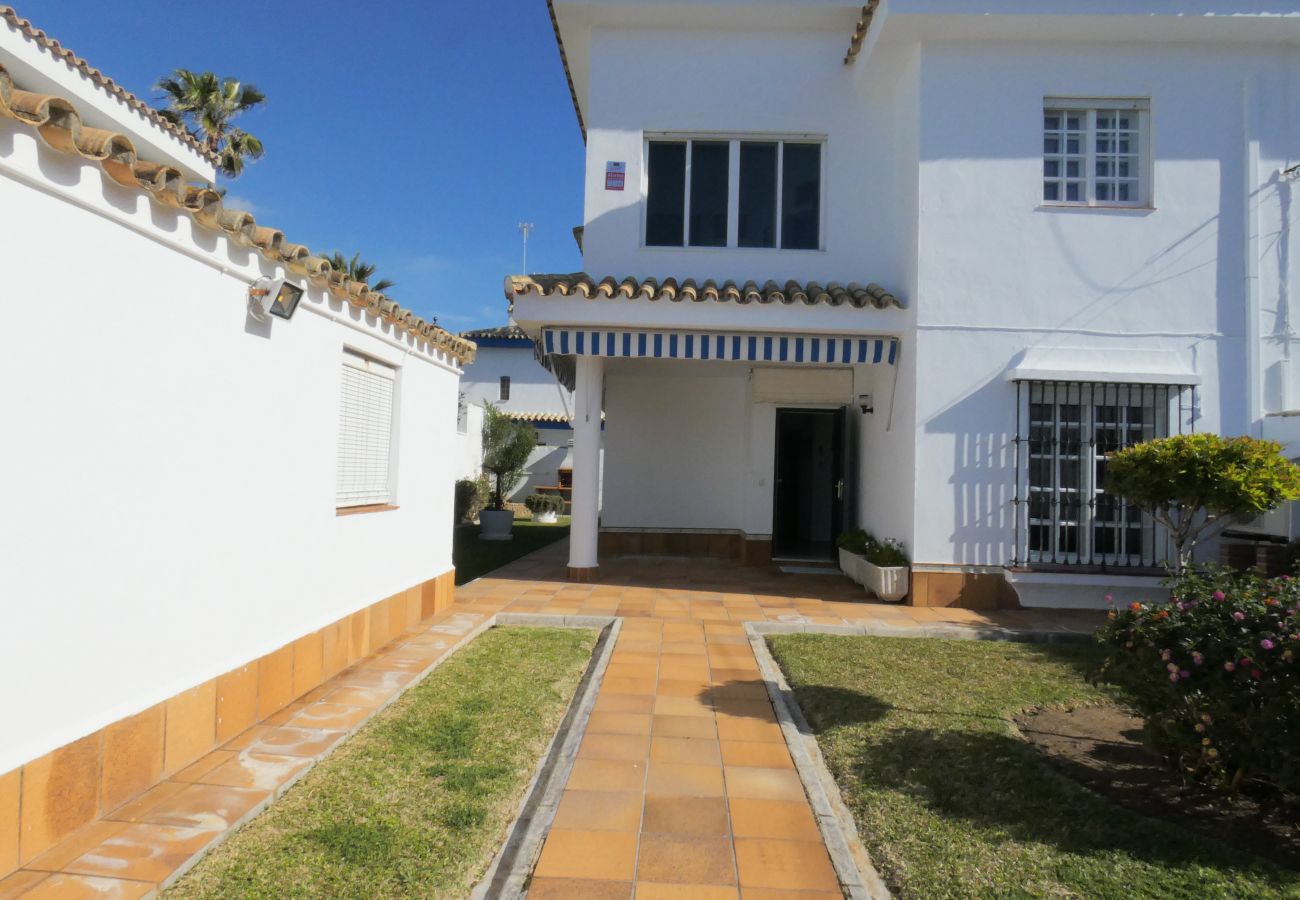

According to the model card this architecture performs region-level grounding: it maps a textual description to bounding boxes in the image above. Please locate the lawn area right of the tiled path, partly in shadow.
[771,635,1300,899]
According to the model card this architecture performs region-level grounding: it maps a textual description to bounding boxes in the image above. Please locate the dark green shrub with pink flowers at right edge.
[1097,570,1300,792]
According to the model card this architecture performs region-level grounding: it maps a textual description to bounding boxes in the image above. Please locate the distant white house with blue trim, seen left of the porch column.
[460,323,573,502]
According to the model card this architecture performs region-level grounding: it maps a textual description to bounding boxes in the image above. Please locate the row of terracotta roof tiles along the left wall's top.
[0,60,475,363]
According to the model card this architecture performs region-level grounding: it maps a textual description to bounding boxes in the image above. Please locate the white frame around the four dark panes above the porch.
[641,131,827,254]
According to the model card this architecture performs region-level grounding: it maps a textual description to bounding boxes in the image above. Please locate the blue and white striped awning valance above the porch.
[541,328,898,365]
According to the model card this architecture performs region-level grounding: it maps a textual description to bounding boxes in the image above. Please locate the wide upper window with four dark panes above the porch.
[645,138,824,250]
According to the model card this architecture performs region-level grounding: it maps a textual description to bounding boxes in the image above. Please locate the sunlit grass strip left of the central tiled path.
[168,627,597,900]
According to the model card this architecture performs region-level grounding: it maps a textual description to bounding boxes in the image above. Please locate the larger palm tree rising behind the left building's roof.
[155,69,267,178]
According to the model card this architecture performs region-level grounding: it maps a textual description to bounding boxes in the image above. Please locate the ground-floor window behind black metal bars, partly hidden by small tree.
[1013,381,1195,568]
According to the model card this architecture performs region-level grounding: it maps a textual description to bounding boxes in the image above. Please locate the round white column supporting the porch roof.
[568,356,605,581]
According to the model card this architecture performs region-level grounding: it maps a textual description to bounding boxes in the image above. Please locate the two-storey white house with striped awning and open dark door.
[506,0,1300,606]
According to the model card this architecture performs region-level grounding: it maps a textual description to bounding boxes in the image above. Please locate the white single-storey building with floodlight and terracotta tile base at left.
[0,7,473,878]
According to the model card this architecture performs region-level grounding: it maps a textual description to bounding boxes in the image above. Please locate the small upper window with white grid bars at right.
[1043,98,1151,207]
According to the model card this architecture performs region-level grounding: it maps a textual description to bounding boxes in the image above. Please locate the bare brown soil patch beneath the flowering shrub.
[1015,704,1300,869]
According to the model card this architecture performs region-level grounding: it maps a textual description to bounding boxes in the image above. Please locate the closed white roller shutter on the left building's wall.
[335,350,397,509]
